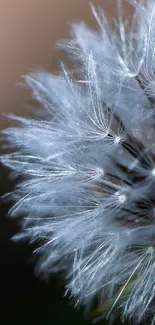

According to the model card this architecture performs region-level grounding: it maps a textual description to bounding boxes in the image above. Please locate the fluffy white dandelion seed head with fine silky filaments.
[1,0,155,324]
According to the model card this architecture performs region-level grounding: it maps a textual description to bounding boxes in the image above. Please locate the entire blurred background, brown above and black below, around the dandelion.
[0,0,132,325]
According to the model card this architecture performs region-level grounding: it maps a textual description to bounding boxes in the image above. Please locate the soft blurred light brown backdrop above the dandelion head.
[0,0,131,127]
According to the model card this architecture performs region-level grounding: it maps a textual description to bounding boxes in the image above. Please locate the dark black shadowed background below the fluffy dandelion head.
[0,166,90,325]
